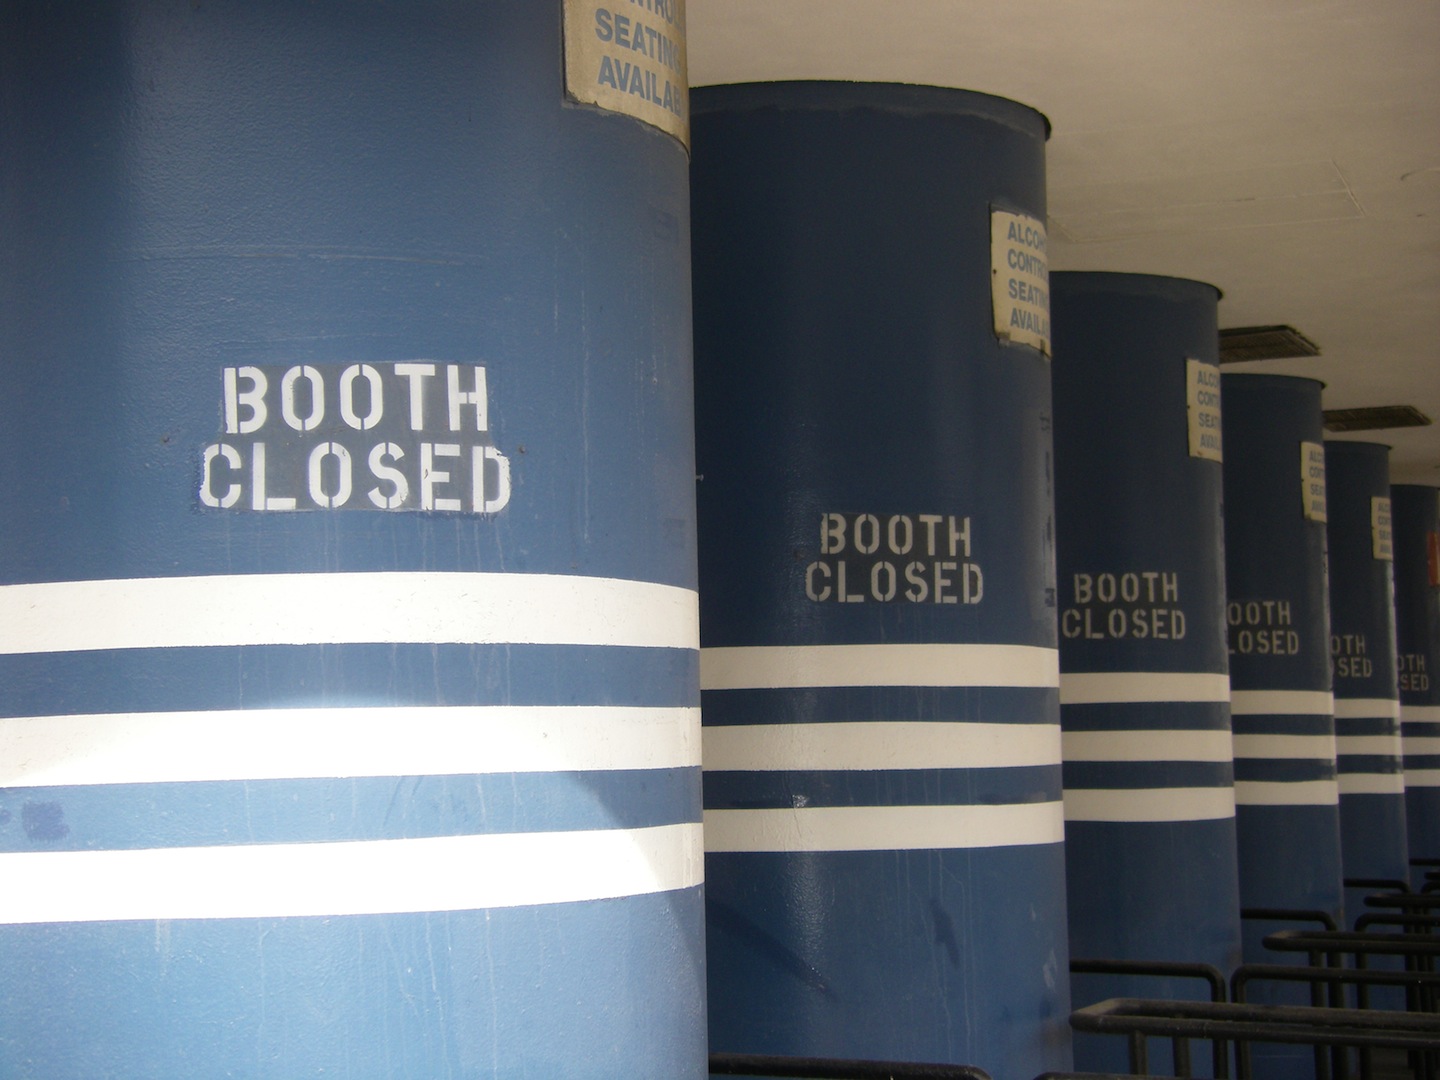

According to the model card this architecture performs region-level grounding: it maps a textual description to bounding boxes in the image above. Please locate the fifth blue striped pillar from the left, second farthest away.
[1325,442,1410,920]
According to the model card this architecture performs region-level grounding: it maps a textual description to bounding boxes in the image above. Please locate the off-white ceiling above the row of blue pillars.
[687,0,1440,484]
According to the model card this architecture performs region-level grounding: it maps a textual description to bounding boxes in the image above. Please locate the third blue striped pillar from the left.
[1053,274,1240,1070]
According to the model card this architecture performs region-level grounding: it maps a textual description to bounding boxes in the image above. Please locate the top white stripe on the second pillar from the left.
[700,644,1060,690]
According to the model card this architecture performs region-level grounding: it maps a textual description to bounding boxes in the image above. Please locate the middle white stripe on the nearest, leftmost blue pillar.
[0,706,700,788]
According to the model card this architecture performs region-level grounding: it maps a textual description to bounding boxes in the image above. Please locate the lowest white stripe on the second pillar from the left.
[706,802,1064,852]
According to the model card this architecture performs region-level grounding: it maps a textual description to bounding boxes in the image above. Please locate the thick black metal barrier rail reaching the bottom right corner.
[1070,998,1440,1080]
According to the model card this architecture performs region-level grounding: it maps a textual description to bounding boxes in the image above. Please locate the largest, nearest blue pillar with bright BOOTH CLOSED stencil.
[0,0,706,1080]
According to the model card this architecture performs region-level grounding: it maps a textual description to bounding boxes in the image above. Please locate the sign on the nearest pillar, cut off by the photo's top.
[564,0,690,148]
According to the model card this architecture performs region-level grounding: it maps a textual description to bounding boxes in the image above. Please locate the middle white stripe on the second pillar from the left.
[703,720,1060,772]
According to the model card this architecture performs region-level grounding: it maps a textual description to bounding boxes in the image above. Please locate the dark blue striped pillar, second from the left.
[693,82,1070,1080]
